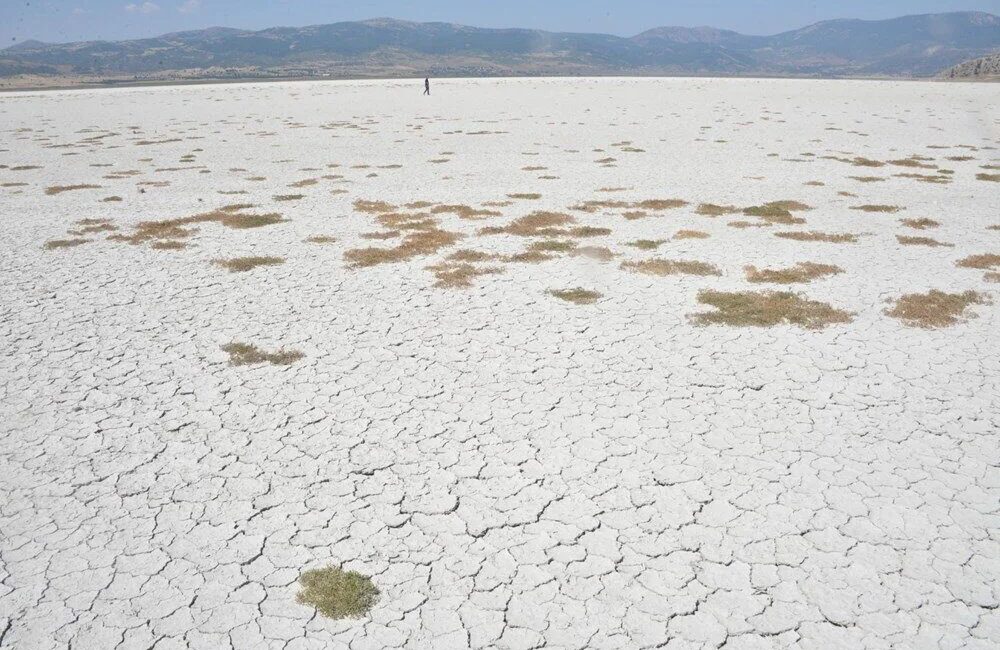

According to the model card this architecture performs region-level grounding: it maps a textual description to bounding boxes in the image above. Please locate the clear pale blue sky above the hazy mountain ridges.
[0,0,1000,47]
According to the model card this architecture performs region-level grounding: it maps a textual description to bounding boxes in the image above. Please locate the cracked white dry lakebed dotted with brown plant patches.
[0,79,1000,650]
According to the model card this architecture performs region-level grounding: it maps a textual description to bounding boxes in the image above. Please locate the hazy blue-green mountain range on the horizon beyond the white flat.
[0,12,1000,85]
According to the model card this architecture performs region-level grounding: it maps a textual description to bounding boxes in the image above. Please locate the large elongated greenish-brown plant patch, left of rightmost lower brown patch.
[692,290,851,329]
